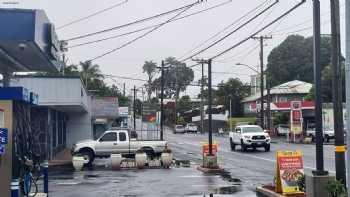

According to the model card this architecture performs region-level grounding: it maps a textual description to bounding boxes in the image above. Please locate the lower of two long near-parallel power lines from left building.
[67,0,232,48]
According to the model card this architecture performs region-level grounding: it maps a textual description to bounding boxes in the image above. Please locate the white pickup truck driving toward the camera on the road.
[229,125,271,152]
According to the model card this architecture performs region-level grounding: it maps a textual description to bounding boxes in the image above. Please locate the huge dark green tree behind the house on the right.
[267,35,331,86]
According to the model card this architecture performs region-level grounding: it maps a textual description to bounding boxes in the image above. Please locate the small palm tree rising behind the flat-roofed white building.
[79,61,103,88]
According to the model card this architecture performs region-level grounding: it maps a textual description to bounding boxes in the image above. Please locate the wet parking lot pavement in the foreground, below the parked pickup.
[49,162,256,197]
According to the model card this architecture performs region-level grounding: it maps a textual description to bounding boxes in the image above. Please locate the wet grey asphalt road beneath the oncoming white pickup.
[165,128,335,190]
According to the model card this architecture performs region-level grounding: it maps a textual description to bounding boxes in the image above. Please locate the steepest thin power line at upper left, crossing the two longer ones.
[88,1,199,61]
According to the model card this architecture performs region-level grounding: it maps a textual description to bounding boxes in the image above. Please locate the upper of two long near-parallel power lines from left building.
[65,0,200,41]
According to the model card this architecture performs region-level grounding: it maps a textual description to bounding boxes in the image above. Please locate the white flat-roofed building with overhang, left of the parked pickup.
[11,76,93,159]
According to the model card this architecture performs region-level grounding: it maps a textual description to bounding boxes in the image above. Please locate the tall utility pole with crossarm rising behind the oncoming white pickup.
[252,36,272,129]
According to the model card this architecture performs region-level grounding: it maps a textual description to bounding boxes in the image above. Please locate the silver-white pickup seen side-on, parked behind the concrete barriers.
[72,129,168,164]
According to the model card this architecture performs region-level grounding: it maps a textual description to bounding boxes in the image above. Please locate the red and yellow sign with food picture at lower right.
[276,151,304,195]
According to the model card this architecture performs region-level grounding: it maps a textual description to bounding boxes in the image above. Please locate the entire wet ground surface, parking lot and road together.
[50,120,334,197]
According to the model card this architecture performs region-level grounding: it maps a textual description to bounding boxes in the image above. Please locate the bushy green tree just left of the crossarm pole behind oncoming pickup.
[216,78,250,116]
